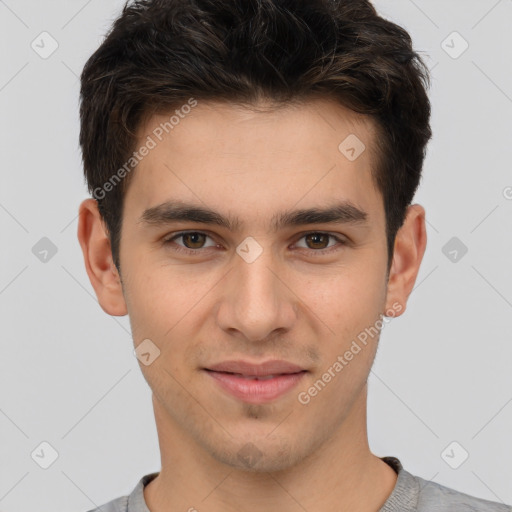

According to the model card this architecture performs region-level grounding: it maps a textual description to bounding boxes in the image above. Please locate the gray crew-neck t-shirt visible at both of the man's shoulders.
[89,457,512,512]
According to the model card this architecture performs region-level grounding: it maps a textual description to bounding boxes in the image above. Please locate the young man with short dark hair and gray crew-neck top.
[78,0,510,512]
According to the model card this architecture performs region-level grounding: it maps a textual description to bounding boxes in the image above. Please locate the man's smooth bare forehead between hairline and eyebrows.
[126,100,381,228]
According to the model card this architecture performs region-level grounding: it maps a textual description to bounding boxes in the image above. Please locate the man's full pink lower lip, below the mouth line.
[205,370,306,404]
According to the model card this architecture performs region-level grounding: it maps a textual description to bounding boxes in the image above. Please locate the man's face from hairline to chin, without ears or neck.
[82,100,418,471]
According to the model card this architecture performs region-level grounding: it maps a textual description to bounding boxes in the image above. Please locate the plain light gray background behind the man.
[0,0,512,512]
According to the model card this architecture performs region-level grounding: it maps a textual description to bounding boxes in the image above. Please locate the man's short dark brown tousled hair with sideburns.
[80,0,432,270]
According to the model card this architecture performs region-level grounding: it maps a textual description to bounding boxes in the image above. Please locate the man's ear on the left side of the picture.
[77,199,127,316]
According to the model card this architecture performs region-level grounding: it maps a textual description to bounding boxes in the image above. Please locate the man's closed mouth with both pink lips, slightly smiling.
[203,361,308,404]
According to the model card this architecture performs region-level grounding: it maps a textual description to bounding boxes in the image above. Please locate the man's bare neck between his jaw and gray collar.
[144,385,397,512]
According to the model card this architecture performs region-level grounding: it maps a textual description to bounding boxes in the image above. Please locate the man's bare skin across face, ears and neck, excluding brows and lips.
[78,100,426,512]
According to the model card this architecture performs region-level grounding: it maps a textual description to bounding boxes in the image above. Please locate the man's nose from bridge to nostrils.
[217,244,299,342]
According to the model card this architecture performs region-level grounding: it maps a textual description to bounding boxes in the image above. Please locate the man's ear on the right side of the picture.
[386,204,427,316]
